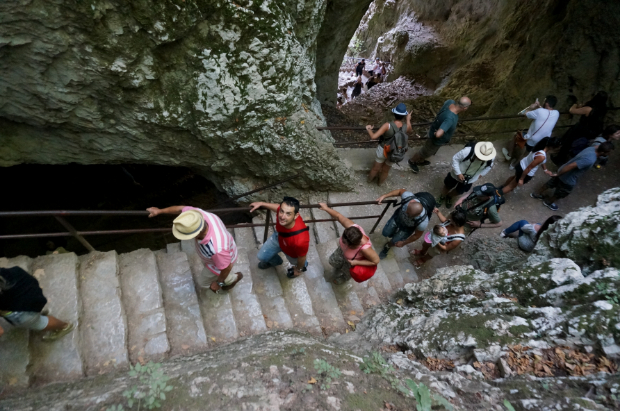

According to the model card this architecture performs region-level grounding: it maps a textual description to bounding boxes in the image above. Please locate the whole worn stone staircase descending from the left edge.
[0,198,417,393]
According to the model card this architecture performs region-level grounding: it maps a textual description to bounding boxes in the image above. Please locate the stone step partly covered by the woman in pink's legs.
[316,239,364,317]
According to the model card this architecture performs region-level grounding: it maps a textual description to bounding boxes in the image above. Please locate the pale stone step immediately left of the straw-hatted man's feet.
[156,253,208,355]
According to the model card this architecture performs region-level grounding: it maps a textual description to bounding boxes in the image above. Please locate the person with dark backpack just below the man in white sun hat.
[454,183,505,230]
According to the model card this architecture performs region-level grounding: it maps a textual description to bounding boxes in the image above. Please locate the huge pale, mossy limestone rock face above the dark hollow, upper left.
[0,0,349,194]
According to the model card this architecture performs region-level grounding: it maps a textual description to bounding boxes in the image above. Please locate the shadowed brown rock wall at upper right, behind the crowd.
[355,0,620,130]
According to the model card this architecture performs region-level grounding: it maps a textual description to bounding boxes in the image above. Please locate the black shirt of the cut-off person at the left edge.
[0,267,47,313]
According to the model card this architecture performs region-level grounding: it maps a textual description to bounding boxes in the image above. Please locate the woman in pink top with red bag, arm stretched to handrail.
[319,203,379,285]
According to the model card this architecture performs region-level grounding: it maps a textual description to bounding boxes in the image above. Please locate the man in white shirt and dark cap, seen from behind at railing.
[502,96,560,170]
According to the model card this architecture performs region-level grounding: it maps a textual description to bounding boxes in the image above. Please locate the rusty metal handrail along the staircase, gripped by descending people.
[0,200,396,251]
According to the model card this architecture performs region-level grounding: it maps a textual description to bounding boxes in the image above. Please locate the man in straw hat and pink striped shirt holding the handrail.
[146,206,243,292]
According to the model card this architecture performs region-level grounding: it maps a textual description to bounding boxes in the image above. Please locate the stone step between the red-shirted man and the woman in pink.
[302,244,347,335]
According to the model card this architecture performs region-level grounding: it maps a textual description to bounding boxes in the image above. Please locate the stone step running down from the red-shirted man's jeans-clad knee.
[249,250,293,329]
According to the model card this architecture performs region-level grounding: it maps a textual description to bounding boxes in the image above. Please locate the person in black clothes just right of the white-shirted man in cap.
[552,91,607,165]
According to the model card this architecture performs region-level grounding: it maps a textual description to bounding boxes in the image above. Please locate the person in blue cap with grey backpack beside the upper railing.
[366,103,411,185]
